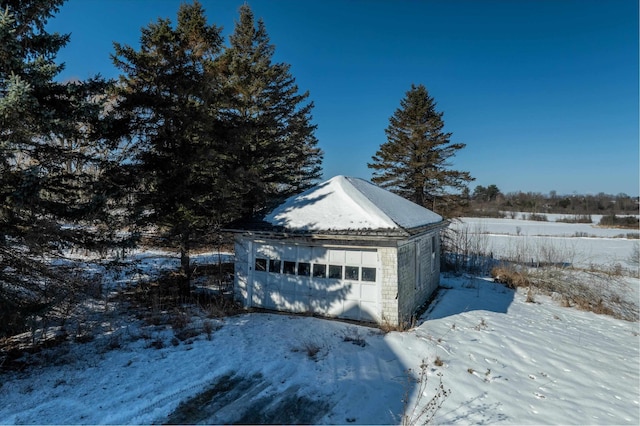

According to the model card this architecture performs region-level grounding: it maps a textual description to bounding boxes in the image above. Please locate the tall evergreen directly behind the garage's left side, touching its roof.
[221,4,322,214]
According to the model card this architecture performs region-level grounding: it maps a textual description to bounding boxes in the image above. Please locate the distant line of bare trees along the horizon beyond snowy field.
[460,185,640,216]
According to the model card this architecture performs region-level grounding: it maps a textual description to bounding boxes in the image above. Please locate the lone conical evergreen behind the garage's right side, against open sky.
[368,84,474,212]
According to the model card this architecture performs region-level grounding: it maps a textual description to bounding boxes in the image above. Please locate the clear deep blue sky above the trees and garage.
[48,0,640,196]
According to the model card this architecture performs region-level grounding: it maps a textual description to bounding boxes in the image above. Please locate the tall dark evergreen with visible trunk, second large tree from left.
[112,2,227,292]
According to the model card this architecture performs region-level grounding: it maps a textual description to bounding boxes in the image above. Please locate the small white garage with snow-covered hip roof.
[227,176,447,325]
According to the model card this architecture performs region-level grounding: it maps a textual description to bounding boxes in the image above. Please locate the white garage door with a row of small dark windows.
[250,244,380,321]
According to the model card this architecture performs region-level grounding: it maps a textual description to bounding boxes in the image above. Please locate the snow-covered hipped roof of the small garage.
[263,176,442,231]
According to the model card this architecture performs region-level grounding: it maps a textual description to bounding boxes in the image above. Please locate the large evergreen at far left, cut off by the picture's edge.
[0,0,120,335]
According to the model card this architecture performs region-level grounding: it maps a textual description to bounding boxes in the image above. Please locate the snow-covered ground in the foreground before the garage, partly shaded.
[0,277,640,425]
